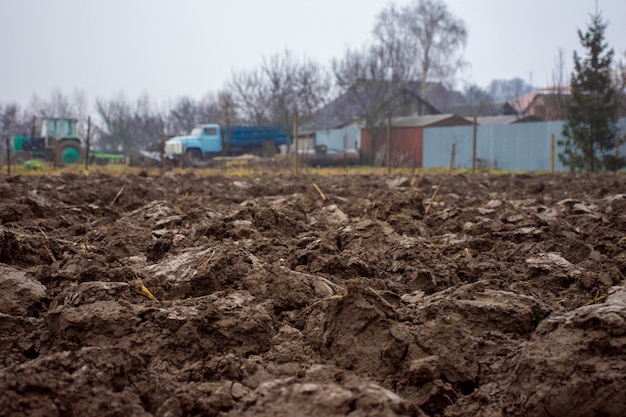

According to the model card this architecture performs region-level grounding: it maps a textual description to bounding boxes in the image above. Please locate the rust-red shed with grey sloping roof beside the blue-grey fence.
[361,114,473,167]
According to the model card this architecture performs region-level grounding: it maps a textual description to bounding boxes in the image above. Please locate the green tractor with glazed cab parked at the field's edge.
[11,117,82,166]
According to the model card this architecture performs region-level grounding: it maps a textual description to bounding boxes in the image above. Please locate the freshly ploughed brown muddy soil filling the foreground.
[0,173,626,417]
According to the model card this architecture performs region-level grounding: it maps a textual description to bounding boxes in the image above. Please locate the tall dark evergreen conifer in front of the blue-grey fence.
[559,11,626,172]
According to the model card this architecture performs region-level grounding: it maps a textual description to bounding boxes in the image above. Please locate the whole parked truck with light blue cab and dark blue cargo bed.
[165,124,288,166]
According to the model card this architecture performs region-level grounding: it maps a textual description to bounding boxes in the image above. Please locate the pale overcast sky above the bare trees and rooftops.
[0,0,626,110]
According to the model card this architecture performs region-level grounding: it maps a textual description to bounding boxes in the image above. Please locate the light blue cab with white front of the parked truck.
[165,124,222,161]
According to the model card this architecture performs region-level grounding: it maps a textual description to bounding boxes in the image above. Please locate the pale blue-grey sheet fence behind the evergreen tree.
[423,118,626,171]
